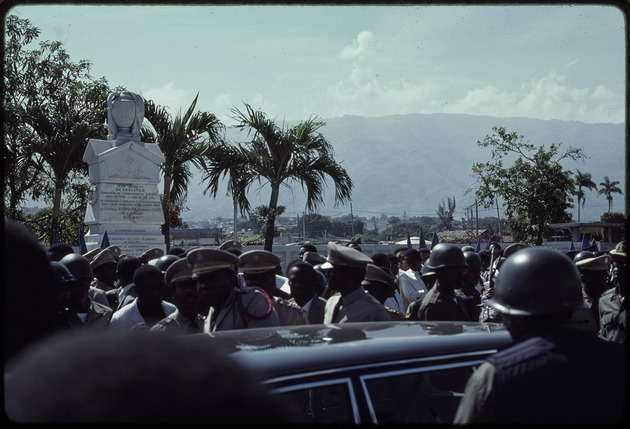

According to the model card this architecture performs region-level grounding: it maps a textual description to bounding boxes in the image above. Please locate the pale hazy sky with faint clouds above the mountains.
[9,5,625,125]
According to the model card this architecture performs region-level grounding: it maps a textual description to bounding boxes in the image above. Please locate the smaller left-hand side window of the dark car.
[273,378,359,424]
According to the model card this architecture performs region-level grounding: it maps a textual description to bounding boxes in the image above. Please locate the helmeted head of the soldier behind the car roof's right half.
[425,243,468,293]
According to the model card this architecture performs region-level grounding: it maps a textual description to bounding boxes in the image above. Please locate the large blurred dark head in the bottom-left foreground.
[4,331,297,424]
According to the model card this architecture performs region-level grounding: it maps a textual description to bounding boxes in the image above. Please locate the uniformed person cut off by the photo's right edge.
[599,241,628,343]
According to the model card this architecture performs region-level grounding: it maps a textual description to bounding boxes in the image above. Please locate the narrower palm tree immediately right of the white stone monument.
[142,93,225,247]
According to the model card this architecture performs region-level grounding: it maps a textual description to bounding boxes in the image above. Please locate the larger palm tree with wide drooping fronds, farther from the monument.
[202,104,353,251]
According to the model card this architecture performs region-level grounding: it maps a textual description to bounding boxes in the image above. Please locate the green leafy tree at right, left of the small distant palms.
[472,127,583,245]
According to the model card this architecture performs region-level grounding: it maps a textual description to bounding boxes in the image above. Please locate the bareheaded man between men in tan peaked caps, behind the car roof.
[287,261,326,324]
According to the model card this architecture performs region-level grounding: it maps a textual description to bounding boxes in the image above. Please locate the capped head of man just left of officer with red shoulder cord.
[164,259,201,320]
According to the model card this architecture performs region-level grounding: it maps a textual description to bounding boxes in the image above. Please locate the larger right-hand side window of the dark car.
[362,363,476,424]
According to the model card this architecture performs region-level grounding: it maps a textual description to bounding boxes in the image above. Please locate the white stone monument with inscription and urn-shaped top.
[83,91,166,256]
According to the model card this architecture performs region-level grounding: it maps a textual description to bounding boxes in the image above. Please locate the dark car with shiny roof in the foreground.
[198,322,511,424]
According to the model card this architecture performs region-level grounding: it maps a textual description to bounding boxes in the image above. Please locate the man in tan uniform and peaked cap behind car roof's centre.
[322,242,391,323]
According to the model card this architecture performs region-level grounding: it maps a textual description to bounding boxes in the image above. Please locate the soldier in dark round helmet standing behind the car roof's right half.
[418,243,471,322]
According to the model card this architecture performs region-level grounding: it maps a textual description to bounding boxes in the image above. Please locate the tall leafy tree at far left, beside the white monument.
[5,17,109,242]
